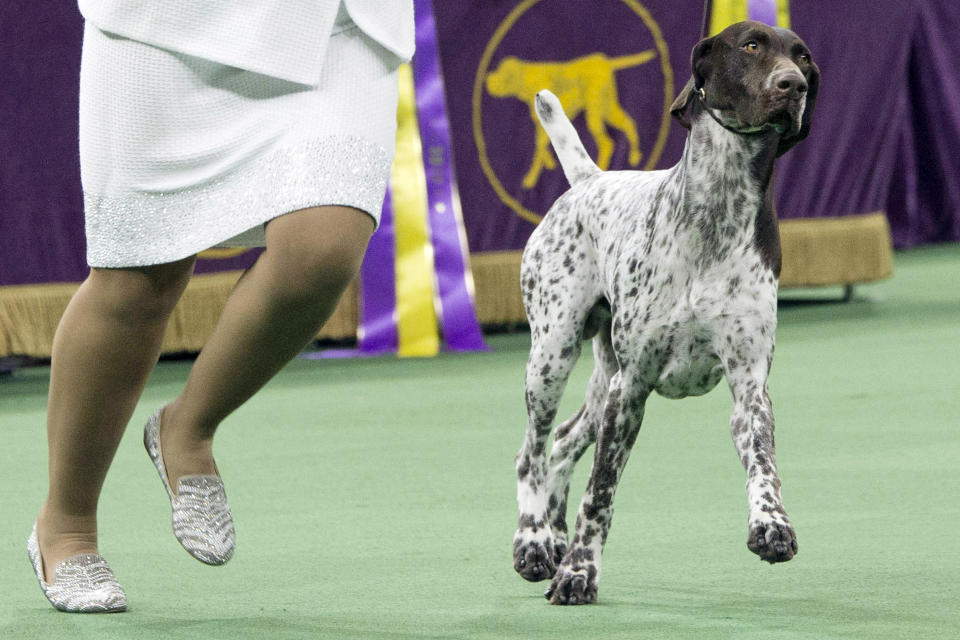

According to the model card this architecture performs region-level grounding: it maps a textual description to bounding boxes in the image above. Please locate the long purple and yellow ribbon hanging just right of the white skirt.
[358,0,487,357]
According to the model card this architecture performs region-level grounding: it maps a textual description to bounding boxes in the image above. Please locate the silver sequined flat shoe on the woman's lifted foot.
[143,407,235,565]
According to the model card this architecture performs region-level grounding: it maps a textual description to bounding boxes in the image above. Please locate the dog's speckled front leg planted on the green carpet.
[544,372,650,604]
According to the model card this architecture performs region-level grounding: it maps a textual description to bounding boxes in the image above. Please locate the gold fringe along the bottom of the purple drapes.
[0,212,893,358]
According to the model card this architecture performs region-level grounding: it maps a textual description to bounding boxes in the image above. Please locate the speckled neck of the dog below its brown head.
[677,110,780,274]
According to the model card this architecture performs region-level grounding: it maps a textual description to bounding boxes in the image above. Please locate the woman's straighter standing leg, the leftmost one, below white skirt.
[37,257,194,582]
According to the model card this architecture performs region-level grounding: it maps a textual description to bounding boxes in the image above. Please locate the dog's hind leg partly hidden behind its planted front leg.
[547,322,617,564]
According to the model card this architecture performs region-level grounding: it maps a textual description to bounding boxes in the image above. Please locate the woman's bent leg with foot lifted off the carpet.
[161,206,374,490]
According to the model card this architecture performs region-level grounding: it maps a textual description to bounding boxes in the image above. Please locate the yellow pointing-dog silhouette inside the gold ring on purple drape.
[486,49,657,189]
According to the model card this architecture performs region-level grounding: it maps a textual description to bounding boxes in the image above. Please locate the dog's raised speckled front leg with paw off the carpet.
[726,358,797,563]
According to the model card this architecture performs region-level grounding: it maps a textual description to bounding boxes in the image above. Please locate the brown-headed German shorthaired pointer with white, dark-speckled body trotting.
[513,22,820,604]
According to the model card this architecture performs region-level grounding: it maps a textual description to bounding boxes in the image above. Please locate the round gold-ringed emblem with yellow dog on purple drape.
[472,0,674,224]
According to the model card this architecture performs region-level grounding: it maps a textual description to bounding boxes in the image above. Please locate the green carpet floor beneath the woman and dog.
[0,246,960,640]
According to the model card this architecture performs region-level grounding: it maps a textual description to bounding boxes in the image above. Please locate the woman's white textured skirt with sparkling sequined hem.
[80,12,397,267]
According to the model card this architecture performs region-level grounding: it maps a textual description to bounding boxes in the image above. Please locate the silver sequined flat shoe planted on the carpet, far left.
[27,524,127,613]
